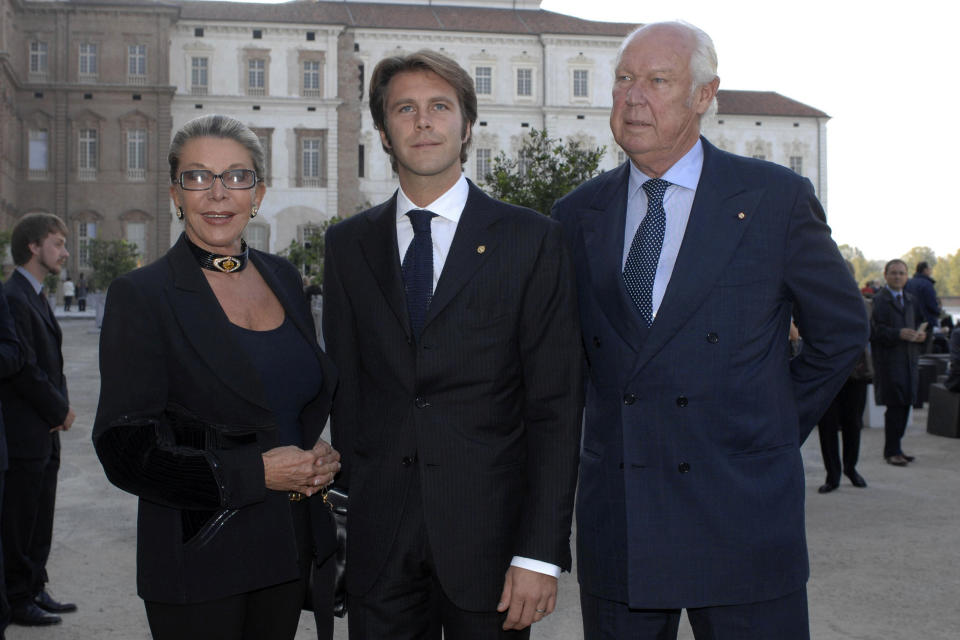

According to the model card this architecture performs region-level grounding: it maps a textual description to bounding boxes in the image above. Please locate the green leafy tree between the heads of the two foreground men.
[482,129,605,214]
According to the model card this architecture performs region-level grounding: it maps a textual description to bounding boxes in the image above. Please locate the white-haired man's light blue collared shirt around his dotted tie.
[620,139,703,318]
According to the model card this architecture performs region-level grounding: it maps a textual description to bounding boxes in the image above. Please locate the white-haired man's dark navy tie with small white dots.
[623,178,670,327]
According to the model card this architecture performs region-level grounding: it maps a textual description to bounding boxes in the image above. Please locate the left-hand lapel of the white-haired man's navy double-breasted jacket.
[577,163,647,351]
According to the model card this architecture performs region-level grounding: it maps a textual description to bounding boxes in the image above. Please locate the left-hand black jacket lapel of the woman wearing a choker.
[167,235,272,411]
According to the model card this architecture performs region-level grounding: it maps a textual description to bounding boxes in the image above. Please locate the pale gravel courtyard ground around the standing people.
[7,318,960,640]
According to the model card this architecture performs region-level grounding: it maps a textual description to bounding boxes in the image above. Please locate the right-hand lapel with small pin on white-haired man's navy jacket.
[634,139,764,371]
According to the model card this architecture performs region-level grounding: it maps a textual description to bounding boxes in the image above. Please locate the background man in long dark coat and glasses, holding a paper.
[870,260,927,467]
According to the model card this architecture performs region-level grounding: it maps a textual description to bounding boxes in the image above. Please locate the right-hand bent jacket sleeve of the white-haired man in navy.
[783,180,867,442]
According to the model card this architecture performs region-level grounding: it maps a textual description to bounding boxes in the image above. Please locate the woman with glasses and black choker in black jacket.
[93,115,340,640]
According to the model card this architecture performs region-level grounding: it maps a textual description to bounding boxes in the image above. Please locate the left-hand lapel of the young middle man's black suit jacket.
[360,193,413,337]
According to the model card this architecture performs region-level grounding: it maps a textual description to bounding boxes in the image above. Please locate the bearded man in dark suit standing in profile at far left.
[0,213,77,626]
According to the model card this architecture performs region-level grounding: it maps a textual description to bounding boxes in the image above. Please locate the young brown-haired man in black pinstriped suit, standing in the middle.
[323,51,582,640]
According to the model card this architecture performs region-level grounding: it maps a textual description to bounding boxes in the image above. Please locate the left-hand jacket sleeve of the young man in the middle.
[322,227,359,489]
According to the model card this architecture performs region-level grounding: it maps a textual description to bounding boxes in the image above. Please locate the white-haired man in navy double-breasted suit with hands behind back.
[554,23,867,640]
